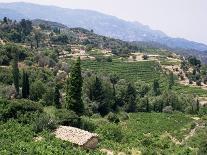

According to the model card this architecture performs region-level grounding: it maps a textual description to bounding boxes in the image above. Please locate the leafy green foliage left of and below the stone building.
[0,121,101,155]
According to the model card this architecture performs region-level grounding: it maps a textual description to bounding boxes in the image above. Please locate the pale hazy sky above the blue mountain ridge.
[0,0,207,44]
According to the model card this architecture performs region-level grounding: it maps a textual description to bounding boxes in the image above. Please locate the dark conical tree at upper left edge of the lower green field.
[124,83,137,112]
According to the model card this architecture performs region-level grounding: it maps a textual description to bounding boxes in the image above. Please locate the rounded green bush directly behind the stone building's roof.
[55,109,80,127]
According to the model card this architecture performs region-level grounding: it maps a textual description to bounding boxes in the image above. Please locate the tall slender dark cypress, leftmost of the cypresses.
[10,45,19,95]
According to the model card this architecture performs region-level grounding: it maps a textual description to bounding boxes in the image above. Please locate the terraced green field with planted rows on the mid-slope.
[82,59,161,82]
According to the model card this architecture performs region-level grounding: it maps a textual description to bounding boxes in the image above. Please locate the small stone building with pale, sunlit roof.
[55,126,98,149]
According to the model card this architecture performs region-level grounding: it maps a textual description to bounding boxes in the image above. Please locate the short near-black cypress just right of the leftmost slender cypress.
[22,71,30,98]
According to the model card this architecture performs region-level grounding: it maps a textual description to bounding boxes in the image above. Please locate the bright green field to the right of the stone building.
[92,113,205,154]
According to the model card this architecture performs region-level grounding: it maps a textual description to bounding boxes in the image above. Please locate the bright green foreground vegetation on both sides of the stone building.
[0,113,207,155]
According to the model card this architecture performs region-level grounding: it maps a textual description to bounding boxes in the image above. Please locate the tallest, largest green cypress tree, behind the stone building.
[66,57,84,115]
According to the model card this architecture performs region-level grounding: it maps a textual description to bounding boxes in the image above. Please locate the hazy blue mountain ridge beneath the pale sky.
[0,2,207,51]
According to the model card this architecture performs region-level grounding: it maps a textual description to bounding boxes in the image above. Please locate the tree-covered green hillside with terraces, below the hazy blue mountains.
[0,18,207,155]
